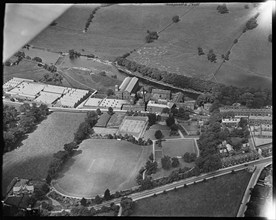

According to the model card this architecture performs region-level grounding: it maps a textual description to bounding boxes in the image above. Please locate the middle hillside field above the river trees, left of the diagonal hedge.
[129,4,258,78]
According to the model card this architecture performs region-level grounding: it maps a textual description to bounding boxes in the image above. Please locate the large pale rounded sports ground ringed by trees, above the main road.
[54,139,150,198]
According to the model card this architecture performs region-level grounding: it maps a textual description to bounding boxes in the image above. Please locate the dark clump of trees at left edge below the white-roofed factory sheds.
[3,103,49,152]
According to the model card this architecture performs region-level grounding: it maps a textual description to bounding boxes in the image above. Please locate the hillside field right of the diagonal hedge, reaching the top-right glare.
[216,4,272,89]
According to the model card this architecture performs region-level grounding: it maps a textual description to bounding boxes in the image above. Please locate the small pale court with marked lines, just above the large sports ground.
[118,116,148,138]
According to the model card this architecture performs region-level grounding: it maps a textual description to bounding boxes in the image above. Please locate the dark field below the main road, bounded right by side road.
[132,170,251,217]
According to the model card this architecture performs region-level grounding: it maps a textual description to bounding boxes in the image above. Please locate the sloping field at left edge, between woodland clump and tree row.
[2,112,85,195]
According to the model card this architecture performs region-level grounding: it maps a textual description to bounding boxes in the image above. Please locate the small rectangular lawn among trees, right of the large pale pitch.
[162,139,197,157]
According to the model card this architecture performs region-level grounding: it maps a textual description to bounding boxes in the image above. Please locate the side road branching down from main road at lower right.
[237,162,272,217]
